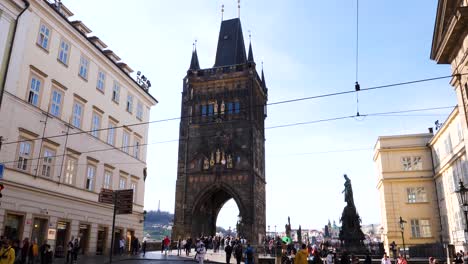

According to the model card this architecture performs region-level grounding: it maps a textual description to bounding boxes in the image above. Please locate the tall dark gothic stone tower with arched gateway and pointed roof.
[172,18,267,244]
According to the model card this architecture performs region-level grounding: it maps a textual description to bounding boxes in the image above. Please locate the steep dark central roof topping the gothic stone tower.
[214,18,246,67]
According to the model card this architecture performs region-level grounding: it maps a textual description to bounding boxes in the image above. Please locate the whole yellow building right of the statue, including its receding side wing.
[374,107,468,252]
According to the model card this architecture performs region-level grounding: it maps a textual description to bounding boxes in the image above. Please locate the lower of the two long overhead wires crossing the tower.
[0,106,455,164]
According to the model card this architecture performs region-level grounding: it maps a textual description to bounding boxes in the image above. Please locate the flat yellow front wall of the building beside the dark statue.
[374,133,440,255]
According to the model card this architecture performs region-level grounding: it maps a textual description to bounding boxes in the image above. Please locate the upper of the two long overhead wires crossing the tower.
[3,73,468,145]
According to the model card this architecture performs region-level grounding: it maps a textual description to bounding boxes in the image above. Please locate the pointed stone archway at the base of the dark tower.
[191,183,248,237]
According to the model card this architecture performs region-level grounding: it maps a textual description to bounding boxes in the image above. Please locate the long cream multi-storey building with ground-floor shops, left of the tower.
[0,0,157,255]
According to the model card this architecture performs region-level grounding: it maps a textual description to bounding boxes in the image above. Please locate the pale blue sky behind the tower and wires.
[63,0,456,231]
